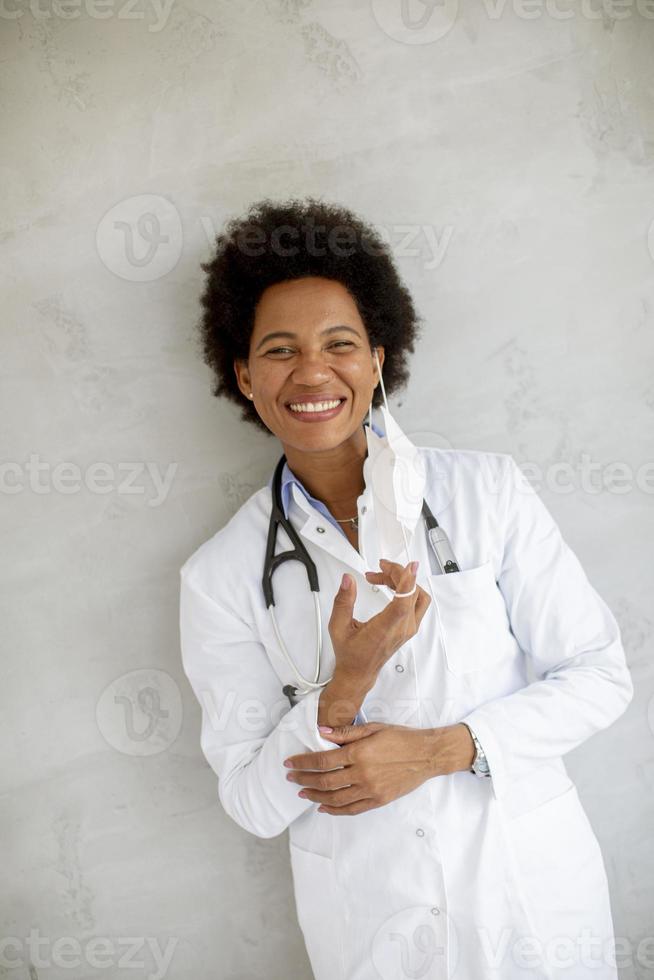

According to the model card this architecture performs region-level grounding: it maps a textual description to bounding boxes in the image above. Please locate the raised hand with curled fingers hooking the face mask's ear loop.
[328,558,431,687]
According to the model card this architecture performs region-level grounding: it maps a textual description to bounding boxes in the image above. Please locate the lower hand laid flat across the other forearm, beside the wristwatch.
[285,722,475,816]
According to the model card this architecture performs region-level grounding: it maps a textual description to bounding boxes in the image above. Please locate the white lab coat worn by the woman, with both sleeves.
[180,447,633,980]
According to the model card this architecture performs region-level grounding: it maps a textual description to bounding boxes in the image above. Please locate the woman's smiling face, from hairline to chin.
[234,276,384,451]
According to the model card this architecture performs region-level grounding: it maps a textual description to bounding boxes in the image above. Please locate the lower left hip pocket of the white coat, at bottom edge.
[289,841,345,980]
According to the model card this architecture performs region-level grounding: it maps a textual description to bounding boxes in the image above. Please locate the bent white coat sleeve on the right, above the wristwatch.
[461,454,633,799]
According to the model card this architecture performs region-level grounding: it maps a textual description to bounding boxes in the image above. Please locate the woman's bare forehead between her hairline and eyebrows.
[254,276,364,334]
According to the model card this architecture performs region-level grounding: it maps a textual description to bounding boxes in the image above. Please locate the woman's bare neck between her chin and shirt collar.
[284,426,368,518]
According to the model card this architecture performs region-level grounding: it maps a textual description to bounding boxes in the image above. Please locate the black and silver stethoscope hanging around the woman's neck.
[262,455,459,707]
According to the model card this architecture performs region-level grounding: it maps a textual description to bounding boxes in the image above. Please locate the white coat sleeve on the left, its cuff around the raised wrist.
[180,570,339,837]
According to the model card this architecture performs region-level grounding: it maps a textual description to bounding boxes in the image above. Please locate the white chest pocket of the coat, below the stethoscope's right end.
[428,560,512,674]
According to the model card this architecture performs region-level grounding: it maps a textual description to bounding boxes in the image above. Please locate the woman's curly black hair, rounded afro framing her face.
[199,197,422,435]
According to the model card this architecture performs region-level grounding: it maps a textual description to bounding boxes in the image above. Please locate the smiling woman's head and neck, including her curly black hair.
[195,198,426,524]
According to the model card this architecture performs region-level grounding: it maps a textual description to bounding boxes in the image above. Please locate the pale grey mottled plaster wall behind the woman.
[0,0,654,980]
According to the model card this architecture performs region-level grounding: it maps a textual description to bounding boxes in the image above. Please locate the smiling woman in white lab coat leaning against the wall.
[180,198,633,980]
